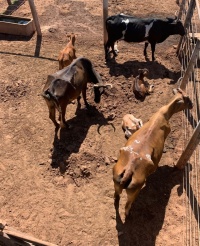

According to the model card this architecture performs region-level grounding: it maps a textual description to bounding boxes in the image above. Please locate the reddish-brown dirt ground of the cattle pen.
[0,0,188,246]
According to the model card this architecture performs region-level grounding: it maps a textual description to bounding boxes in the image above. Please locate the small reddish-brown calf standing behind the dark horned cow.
[58,33,76,70]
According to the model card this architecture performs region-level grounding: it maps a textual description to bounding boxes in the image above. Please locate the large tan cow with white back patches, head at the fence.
[113,89,192,216]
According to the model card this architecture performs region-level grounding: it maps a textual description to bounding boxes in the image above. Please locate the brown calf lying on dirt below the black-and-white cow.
[133,68,154,98]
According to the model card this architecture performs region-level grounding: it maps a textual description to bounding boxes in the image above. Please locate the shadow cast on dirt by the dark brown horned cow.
[51,106,111,173]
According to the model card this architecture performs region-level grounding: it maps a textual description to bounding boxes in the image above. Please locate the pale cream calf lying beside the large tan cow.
[122,114,143,139]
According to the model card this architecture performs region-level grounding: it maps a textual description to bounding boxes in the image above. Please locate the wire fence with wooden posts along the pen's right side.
[177,0,200,245]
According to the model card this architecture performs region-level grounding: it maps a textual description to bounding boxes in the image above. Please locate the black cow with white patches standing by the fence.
[104,14,185,61]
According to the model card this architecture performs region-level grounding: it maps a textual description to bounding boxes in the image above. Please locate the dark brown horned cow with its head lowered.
[42,57,112,128]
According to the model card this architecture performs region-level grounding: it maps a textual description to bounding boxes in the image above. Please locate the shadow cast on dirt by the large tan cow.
[114,166,183,246]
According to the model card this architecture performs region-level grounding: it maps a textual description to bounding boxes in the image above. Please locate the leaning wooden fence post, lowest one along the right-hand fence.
[176,121,200,169]
